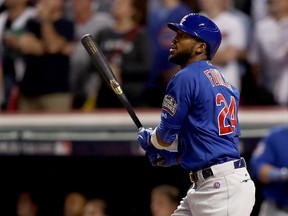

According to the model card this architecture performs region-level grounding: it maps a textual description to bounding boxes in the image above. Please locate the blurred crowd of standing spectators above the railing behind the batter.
[0,0,288,112]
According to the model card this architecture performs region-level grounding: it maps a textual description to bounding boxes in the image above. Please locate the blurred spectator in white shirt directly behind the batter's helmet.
[198,0,248,91]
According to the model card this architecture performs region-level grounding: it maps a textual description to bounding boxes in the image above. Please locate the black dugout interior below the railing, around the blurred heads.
[0,155,261,216]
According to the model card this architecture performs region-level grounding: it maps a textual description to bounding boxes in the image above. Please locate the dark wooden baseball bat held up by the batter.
[81,34,143,129]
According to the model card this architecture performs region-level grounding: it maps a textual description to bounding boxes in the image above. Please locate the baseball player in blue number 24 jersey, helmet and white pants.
[137,13,255,216]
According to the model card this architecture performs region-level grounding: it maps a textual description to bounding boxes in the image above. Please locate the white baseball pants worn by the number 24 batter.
[172,161,255,216]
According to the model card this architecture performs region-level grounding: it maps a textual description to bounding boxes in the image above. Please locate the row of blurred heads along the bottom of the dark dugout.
[13,184,182,216]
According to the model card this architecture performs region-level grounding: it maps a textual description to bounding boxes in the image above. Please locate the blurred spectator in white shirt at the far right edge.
[248,0,288,106]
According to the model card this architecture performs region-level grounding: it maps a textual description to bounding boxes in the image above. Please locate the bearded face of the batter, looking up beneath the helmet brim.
[169,30,206,67]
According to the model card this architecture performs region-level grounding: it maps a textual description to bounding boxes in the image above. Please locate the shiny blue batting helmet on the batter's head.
[167,13,222,60]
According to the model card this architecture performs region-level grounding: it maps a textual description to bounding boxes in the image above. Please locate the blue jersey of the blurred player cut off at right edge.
[249,125,288,205]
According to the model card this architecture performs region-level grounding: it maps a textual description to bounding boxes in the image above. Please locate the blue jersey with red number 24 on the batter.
[157,60,240,172]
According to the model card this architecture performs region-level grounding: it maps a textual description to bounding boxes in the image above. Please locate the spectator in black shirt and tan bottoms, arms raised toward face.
[18,0,74,112]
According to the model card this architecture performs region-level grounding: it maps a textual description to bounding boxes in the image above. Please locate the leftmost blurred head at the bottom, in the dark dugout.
[16,191,39,216]
